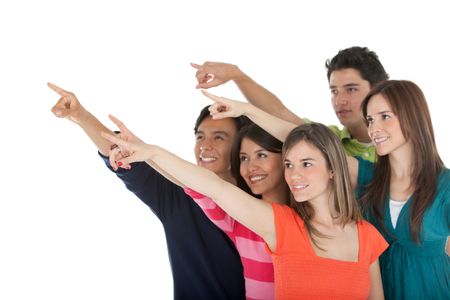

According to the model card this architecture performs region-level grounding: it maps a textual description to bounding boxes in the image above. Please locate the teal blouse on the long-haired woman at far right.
[358,159,450,299]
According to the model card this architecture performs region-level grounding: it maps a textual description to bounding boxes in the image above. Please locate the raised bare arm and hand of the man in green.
[191,62,303,125]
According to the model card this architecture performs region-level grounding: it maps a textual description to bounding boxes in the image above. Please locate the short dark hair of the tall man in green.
[325,46,389,87]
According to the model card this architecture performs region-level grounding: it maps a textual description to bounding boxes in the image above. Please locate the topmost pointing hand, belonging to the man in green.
[191,62,241,89]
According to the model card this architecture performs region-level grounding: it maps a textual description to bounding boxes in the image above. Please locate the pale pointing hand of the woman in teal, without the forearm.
[202,90,249,120]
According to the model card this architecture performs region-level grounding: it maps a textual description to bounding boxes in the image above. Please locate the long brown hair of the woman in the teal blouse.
[361,80,444,243]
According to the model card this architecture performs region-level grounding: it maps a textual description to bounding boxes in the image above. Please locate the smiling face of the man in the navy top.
[194,117,236,178]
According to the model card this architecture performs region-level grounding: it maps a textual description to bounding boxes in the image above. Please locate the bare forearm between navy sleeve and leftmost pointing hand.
[78,112,115,156]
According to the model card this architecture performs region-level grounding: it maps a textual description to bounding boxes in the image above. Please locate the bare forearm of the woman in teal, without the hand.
[244,105,297,142]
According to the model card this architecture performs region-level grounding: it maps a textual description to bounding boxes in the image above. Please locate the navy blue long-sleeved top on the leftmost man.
[100,154,245,300]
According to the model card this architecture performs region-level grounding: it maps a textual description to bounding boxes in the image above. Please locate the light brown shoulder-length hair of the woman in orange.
[283,123,362,249]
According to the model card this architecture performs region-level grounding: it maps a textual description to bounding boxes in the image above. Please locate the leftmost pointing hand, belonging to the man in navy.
[47,82,88,124]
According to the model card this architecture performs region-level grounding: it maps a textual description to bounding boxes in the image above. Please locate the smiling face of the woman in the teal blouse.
[366,94,407,156]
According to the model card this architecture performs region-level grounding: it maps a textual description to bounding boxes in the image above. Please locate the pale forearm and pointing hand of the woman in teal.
[202,91,297,142]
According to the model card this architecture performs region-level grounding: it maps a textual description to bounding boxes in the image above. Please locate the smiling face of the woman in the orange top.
[284,140,333,202]
